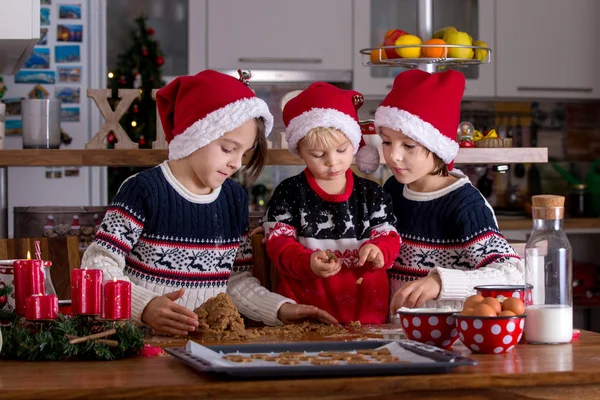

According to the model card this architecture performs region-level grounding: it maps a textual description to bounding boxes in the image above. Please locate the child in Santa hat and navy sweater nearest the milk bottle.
[375,70,524,313]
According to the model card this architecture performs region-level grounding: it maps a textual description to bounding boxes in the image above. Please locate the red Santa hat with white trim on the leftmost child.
[156,70,273,160]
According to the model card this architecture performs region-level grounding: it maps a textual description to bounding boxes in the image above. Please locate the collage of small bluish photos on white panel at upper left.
[2,0,89,178]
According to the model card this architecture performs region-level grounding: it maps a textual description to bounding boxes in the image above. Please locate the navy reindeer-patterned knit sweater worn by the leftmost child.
[83,162,289,324]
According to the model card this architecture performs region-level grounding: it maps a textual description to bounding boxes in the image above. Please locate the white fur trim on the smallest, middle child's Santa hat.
[285,108,361,153]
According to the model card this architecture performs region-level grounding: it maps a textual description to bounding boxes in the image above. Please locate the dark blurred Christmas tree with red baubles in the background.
[107,16,165,200]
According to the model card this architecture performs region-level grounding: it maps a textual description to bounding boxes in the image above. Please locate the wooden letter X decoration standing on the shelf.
[85,89,140,149]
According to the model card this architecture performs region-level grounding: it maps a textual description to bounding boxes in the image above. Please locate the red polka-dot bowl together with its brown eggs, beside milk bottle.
[456,295,525,354]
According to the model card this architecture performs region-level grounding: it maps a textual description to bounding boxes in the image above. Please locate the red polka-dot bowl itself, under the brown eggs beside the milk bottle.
[456,315,525,354]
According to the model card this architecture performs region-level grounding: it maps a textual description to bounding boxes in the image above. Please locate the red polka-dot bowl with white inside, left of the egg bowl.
[398,308,458,349]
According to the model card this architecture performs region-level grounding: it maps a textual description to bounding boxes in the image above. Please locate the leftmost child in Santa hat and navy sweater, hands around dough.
[82,70,336,335]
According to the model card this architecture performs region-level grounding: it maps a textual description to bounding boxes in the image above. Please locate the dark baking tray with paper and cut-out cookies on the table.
[165,340,477,379]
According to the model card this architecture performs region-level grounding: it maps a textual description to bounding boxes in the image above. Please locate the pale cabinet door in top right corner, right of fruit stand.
[496,0,600,98]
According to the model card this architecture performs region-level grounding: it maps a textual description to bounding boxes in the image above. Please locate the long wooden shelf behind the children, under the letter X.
[0,147,548,167]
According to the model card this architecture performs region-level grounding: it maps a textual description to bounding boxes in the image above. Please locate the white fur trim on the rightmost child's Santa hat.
[375,106,458,164]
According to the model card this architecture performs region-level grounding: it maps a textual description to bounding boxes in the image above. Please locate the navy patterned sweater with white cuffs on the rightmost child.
[384,174,523,307]
